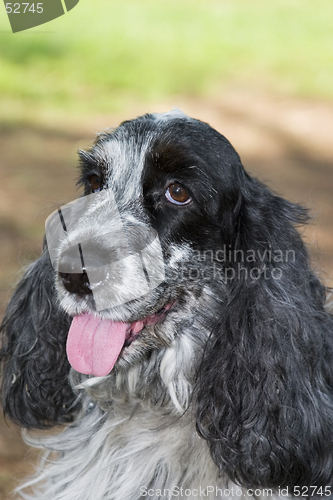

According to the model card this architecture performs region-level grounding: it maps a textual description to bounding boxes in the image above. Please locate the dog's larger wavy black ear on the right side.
[197,177,333,488]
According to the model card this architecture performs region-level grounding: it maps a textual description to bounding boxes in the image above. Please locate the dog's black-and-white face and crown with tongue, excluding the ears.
[46,112,247,375]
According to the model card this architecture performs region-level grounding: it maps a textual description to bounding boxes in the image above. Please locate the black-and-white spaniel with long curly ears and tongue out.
[1,110,333,500]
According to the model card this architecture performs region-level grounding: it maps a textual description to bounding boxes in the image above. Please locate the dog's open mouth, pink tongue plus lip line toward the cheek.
[67,302,175,377]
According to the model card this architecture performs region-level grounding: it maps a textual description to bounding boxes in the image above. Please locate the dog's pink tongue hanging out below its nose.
[67,314,130,377]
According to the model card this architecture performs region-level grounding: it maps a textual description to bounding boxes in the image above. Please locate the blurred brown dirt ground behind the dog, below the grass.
[0,91,333,500]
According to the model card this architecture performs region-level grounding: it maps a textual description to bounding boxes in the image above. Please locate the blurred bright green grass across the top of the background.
[0,0,333,119]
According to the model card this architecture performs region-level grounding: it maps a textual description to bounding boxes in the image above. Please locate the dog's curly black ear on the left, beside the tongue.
[0,250,77,428]
